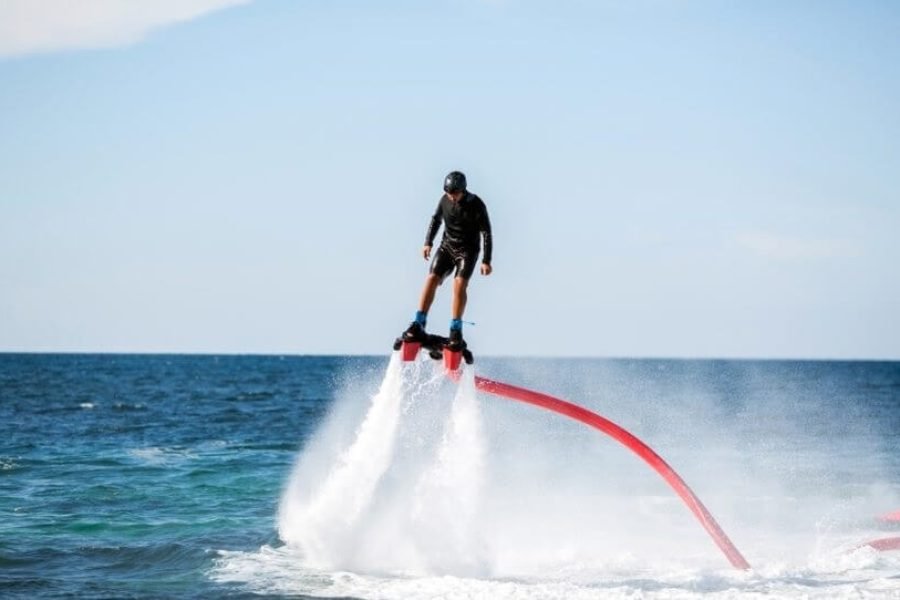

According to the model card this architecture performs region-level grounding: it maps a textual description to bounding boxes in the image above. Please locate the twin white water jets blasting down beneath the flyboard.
[278,353,485,575]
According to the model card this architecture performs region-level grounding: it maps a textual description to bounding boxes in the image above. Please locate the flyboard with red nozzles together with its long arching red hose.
[394,326,750,570]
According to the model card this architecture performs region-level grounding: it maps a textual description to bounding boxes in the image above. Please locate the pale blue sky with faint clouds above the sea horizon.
[0,0,900,360]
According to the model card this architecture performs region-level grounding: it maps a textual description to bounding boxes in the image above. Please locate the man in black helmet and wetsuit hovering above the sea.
[403,171,493,350]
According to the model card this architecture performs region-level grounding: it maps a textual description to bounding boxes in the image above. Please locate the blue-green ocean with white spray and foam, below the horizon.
[0,353,900,599]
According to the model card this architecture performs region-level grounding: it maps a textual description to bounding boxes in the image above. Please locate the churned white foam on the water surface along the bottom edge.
[210,546,900,600]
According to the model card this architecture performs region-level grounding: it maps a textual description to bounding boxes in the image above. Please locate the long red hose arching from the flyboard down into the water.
[464,372,750,569]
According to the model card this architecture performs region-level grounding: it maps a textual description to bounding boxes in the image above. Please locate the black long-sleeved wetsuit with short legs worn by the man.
[425,192,493,279]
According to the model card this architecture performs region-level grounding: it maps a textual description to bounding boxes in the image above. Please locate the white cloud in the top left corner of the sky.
[0,0,251,57]
